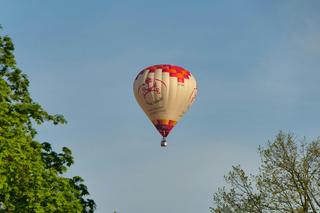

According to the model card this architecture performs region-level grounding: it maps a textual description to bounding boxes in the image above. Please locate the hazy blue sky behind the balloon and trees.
[0,0,320,213]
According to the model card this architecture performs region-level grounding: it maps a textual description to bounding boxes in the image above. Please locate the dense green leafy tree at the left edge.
[0,27,96,213]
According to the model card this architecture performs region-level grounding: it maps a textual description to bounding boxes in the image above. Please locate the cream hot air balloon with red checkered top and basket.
[133,64,197,147]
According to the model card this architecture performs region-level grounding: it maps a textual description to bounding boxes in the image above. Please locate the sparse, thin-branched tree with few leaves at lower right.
[210,132,320,213]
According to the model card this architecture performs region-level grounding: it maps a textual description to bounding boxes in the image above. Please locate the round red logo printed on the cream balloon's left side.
[138,78,167,105]
